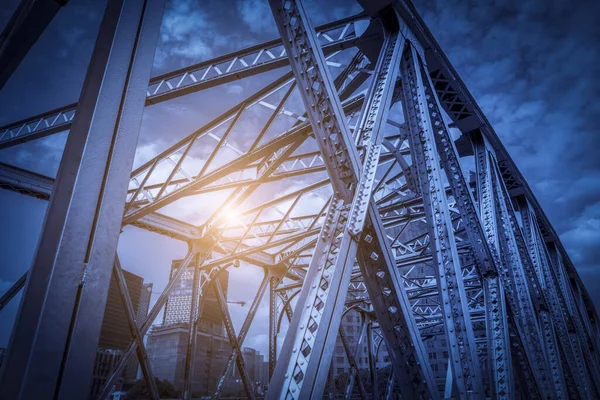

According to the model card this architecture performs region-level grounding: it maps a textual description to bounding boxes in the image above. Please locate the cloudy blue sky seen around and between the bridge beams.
[0,0,600,358]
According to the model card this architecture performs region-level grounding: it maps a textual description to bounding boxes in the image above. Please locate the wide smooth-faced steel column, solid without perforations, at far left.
[0,0,164,399]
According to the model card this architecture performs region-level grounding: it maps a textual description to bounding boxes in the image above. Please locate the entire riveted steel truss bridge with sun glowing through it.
[0,0,600,399]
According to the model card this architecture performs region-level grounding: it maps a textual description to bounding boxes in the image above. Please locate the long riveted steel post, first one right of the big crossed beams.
[401,46,484,398]
